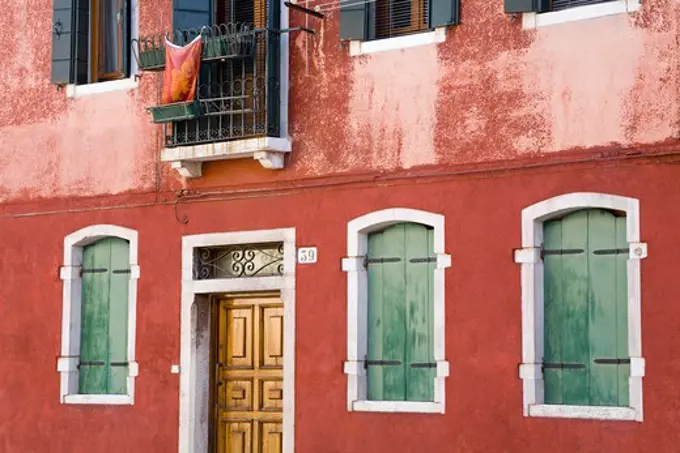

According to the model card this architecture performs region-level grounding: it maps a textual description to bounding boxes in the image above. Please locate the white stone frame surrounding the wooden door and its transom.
[177,228,297,453]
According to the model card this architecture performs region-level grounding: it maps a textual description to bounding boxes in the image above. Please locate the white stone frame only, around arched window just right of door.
[342,208,451,414]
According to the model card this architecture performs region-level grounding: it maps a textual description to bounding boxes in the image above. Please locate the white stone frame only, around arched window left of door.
[57,225,140,405]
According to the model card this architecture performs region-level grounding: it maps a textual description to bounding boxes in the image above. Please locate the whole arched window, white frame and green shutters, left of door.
[57,225,139,404]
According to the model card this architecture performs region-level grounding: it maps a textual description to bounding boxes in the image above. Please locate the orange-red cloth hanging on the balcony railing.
[161,35,203,104]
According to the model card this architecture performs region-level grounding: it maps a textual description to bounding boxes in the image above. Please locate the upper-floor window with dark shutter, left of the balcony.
[52,0,135,84]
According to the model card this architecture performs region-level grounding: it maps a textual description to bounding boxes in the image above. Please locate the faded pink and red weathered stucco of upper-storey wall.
[0,0,680,201]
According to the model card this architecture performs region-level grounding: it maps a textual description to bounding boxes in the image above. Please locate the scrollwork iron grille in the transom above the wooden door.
[194,242,283,280]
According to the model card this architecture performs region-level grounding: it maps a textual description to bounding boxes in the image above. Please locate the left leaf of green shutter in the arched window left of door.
[79,239,111,394]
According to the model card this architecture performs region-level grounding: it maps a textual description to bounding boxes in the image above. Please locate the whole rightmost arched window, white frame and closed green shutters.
[515,193,646,421]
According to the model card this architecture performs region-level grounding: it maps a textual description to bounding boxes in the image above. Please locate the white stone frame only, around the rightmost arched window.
[515,192,647,422]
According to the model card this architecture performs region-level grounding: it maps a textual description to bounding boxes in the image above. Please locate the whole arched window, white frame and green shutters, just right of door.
[343,209,450,413]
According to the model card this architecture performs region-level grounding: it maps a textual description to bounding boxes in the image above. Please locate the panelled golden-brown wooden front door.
[213,296,283,453]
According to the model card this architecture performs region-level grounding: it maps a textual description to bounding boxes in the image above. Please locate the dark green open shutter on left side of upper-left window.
[51,0,90,85]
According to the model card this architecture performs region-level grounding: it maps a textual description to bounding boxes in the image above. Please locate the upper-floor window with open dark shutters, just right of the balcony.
[340,0,459,41]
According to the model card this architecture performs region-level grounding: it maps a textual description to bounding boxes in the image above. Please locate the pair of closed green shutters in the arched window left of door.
[79,238,130,394]
